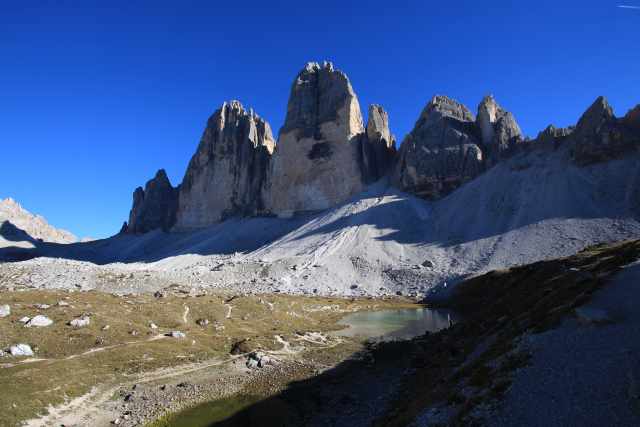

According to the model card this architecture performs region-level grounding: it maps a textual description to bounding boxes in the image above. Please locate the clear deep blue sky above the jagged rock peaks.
[0,0,640,237]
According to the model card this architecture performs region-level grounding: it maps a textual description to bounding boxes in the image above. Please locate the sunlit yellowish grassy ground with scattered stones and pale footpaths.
[0,280,409,426]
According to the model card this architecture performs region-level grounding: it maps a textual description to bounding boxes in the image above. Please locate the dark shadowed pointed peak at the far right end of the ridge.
[571,96,640,165]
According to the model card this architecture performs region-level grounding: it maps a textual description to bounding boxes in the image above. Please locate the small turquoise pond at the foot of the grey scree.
[336,308,456,341]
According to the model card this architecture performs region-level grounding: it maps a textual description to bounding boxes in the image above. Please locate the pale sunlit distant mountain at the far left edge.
[0,198,78,243]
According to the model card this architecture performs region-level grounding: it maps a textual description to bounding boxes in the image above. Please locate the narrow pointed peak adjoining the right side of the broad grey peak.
[476,95,523,164]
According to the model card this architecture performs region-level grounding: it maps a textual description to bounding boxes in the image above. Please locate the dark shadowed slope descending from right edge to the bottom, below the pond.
[201,240,640,427]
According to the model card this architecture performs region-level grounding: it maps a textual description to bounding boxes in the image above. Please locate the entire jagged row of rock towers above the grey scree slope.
[121,62,640,234]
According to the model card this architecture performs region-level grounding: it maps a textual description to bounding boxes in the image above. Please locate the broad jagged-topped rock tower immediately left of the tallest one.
[176,101,275,229]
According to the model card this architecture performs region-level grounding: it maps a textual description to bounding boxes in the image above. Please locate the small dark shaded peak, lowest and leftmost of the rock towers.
[126,169,179,233]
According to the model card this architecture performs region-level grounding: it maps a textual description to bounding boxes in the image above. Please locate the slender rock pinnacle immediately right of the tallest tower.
[362,104,396,184]
